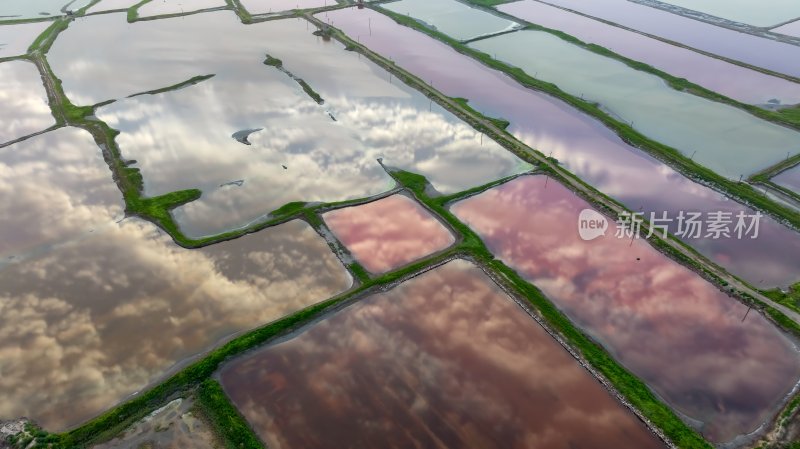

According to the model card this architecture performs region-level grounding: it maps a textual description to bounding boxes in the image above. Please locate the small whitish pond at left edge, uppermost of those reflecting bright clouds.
[0,61,56,144]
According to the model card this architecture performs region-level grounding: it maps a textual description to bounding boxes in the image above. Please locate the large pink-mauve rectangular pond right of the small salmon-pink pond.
[452,176,800,443]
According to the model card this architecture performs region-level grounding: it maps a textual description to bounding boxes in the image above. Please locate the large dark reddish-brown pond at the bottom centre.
[220,260,664,449]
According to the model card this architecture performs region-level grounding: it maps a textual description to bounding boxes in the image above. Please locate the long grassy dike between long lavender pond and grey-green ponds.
[370,5,800,233]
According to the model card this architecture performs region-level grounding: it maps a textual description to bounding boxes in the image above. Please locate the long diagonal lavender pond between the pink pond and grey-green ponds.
[328,8,800,287]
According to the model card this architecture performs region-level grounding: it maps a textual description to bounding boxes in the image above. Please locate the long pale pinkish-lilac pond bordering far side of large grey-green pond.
[497,0,800,105]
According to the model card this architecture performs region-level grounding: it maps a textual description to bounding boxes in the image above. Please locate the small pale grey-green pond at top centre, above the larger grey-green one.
[386,0,519,40]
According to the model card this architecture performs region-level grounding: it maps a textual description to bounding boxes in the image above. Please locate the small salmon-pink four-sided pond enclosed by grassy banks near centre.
[323,195,455,273]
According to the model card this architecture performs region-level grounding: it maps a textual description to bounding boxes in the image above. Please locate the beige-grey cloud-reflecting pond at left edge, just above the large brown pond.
[0,128,125,268]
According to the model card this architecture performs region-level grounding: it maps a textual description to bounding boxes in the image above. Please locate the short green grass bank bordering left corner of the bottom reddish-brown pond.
[197,379,264,449]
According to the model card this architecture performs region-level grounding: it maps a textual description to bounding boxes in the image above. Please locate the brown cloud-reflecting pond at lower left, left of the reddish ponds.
[0,219,352,431]
